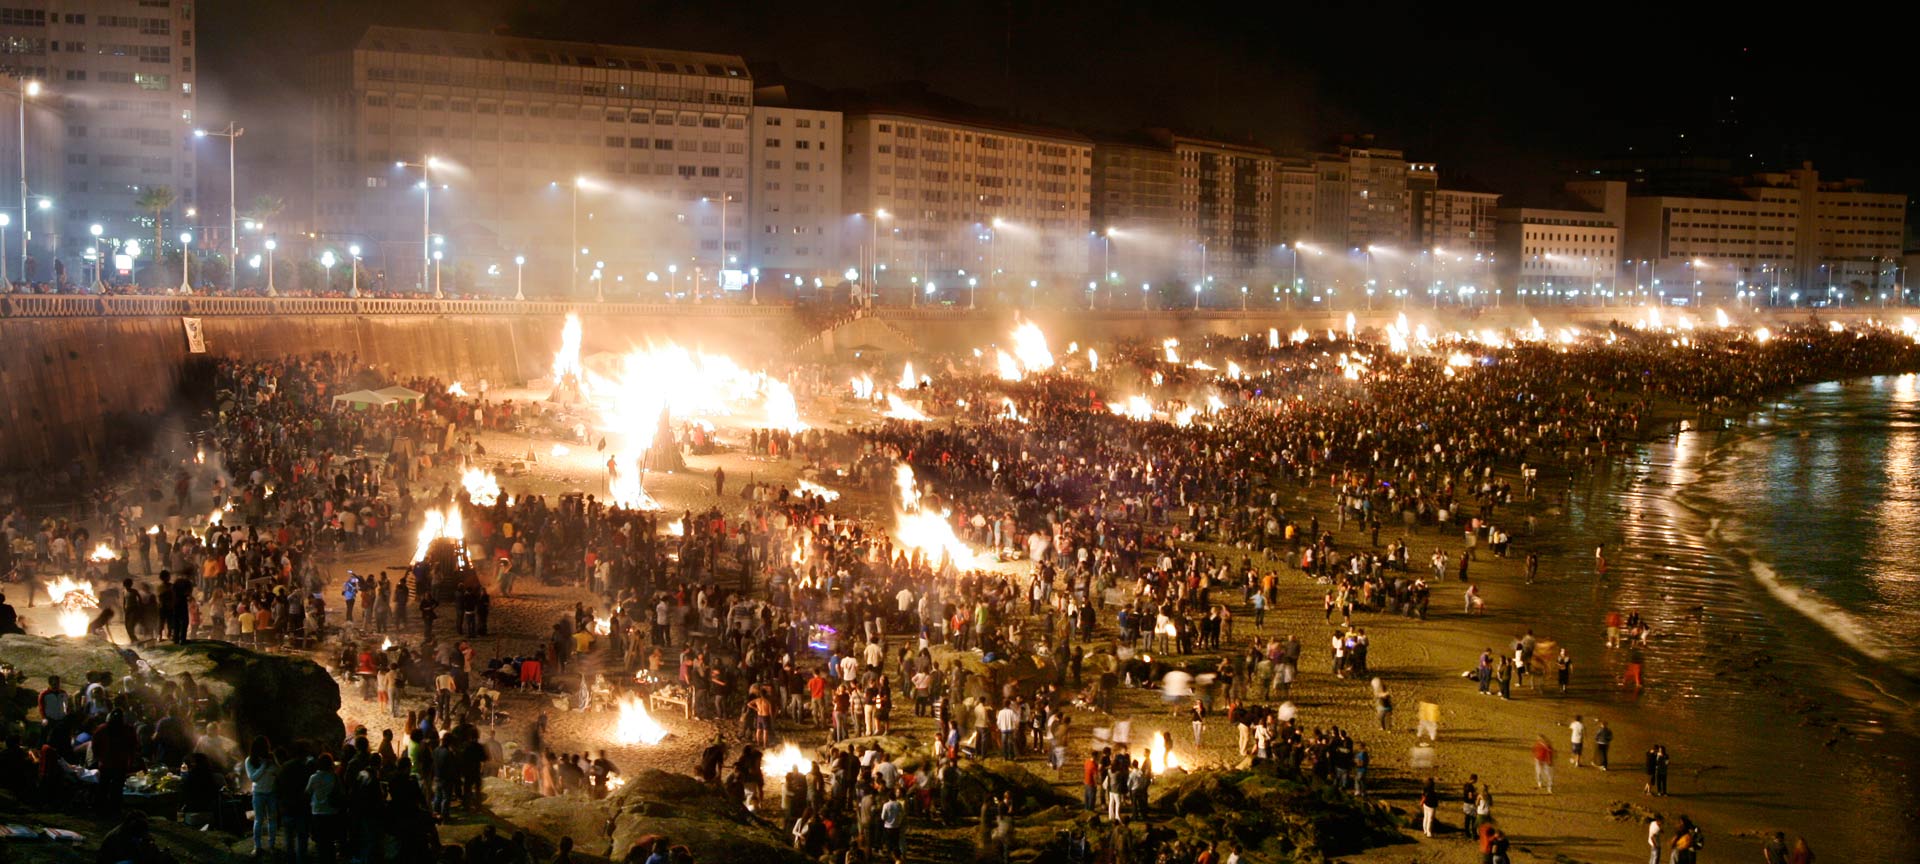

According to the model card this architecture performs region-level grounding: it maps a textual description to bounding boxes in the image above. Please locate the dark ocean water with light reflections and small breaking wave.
[1517,376,1920,860]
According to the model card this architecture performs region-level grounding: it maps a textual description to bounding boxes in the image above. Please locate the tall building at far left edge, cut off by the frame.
[0,0,196,284]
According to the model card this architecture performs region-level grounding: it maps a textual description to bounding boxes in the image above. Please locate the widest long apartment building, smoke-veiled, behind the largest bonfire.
[313,27,748,300]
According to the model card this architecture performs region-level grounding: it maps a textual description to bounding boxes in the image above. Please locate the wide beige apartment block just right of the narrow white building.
[843,102,1096,301]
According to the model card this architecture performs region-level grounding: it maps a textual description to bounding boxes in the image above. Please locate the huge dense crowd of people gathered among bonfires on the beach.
[4,322,1889,864]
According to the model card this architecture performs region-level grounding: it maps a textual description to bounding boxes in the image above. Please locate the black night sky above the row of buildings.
[200,0,1920,227]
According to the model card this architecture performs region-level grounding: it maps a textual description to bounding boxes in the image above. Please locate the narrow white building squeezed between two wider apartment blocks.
[743,86,854,288]
